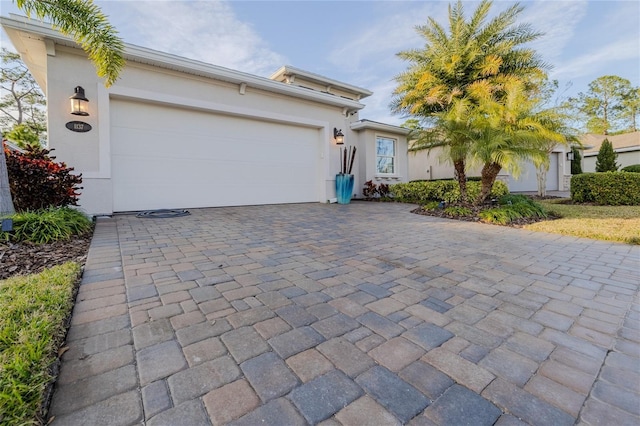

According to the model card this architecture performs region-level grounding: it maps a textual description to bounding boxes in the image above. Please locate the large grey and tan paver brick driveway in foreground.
[51,202,640,426]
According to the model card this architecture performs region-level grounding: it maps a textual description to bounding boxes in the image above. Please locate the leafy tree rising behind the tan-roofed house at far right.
[569,75,631,135]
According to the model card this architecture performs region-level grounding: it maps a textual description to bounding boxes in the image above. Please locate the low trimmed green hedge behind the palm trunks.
[390,179,509,204]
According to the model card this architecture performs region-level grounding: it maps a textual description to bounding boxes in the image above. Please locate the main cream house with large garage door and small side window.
[0,15,408,214]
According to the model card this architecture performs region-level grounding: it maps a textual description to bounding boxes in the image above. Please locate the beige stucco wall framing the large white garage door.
[46,45,364,214]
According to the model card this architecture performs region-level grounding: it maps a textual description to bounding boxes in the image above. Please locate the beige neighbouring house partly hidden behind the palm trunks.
[409,145,571,192]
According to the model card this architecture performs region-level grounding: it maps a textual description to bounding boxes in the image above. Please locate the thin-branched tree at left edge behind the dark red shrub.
[0,48,47,143]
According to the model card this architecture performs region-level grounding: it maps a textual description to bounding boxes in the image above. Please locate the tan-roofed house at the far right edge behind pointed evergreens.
[580,132,640,173]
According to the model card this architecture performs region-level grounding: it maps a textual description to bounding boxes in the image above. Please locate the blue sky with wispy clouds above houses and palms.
[0,0,640,124]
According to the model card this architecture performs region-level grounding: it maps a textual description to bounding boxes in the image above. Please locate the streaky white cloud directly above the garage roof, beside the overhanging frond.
[102,0,287,76]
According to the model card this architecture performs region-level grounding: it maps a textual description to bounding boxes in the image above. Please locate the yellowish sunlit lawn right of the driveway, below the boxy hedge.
[525,200,640,244]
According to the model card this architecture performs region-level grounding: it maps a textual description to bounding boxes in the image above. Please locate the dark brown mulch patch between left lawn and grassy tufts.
[0,232,92,280]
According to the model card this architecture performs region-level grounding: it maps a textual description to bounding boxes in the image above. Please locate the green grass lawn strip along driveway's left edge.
[0,262,80,425]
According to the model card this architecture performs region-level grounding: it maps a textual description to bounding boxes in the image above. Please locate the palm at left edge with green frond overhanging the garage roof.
[0,0,125,215]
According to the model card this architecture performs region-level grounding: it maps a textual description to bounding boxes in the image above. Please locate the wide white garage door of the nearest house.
[110,100,321,211]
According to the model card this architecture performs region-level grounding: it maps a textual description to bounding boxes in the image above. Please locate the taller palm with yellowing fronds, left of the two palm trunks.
[391,0,546,199]
